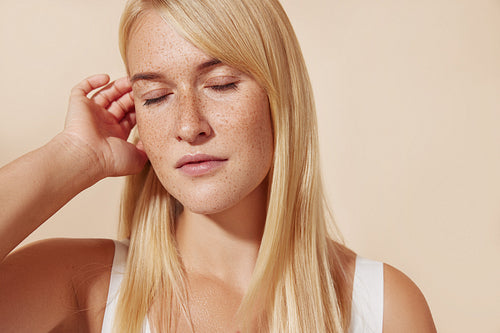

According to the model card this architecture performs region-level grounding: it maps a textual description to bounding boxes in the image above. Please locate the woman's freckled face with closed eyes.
[127,12,273,214]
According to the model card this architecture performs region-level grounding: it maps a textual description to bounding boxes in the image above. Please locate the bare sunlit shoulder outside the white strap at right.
[383,264,436,333]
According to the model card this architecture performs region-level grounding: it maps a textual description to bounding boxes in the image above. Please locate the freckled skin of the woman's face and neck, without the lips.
[127,12,273,292]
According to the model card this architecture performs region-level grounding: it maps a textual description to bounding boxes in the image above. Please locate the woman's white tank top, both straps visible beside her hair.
[101,241,384,333]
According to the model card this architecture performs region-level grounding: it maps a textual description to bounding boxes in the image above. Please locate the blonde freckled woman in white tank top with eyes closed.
[0,0,435,332]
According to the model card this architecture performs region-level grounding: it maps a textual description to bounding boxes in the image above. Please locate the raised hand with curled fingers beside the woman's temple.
[61,74,147,178]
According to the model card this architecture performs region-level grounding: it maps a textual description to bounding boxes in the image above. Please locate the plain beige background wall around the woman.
[0,0,500,333]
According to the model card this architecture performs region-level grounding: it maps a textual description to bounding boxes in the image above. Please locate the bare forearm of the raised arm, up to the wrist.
[0,135,100,262]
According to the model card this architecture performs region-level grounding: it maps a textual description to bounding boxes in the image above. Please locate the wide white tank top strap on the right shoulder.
[349,256,384,333]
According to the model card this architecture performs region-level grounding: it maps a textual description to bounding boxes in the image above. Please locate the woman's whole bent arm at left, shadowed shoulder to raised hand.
[0,75,147,332]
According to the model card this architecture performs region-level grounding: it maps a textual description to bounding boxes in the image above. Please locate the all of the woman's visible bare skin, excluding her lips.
[0,7,435,333]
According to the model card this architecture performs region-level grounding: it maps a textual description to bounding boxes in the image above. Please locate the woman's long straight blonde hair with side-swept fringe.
[115,0,350,332]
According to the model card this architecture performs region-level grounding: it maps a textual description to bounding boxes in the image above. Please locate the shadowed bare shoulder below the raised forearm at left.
[0,238,114,332]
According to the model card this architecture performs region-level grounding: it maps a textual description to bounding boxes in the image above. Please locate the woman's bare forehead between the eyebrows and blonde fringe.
[127,10,211,76]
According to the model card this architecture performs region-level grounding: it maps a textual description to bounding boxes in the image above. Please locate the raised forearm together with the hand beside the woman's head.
[0,75,147,262]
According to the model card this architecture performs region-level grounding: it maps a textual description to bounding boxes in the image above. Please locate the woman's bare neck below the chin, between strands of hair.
[176,182,267,290]
